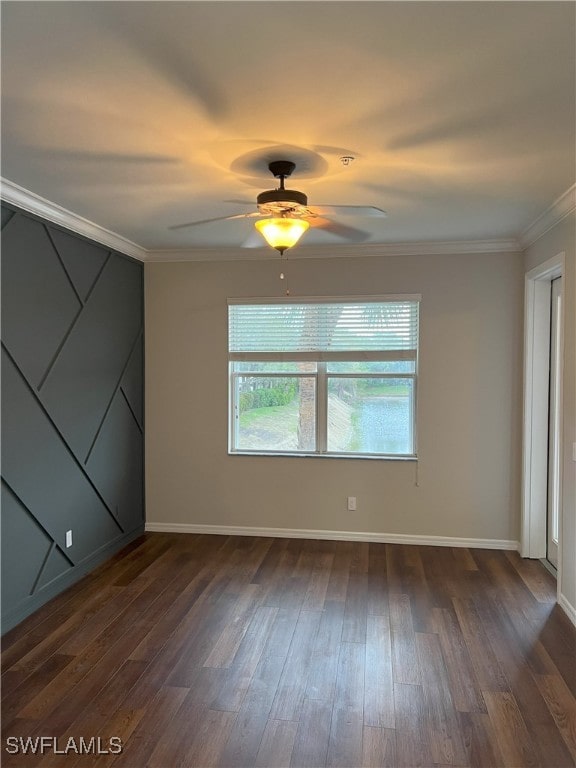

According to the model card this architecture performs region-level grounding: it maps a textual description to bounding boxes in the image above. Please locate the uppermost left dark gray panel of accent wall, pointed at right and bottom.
[2,216,82,388]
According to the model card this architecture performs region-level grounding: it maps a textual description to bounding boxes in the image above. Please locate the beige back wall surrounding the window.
[145,248,524,541]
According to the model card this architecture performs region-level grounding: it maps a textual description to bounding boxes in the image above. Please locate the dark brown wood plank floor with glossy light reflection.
[2,534,576,768]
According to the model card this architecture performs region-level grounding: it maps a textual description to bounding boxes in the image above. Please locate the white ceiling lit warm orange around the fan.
[2,0,576,258]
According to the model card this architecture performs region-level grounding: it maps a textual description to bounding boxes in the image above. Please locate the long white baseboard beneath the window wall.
[146,522,520,550]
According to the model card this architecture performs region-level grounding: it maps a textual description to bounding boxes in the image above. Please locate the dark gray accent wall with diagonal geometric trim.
[1,205,144,632]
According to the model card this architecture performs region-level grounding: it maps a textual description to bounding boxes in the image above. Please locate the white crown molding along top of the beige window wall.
[146,238,522,262]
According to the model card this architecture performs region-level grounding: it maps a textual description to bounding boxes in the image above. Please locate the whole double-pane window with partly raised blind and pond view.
[228,296,420,458]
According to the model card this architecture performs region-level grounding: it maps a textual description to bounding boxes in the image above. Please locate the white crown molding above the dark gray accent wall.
[0,177,147,261]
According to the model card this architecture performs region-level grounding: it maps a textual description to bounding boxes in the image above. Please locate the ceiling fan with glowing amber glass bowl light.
[170,160,386,254]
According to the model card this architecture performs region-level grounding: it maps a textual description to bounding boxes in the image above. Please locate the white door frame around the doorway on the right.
[520,252,565,588]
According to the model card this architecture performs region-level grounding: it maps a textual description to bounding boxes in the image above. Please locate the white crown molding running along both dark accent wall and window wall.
[0,177,520,263]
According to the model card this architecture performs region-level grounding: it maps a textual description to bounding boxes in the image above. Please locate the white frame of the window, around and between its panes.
[228,294,421,461]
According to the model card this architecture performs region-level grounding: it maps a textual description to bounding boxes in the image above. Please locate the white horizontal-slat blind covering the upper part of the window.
[228,296,420,360]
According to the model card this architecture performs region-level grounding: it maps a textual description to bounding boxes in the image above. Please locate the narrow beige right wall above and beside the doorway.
[524,213,576,608]
